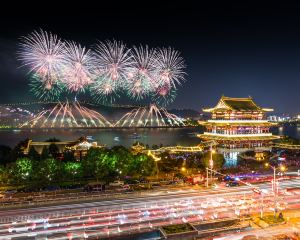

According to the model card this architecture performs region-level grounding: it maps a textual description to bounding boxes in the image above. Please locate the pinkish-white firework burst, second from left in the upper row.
[63,42,95,92]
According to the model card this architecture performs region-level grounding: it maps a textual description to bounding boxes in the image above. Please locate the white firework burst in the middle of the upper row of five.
[94,40,133,87]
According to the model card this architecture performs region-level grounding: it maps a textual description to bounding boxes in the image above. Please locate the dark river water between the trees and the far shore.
[0,125,300,147]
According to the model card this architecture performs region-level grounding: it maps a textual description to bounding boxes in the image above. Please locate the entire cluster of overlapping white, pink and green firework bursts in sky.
[18,30,185,106]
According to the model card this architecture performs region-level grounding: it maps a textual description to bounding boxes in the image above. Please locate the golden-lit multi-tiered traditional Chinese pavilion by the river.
[198,96,279,149]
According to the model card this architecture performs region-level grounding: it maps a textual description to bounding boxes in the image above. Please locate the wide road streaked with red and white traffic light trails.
[0,179,300,239]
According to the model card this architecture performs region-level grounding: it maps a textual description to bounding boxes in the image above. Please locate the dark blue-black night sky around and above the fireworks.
[0,0,300,114]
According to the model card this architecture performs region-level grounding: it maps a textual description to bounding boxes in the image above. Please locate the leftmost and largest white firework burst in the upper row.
[18,30,66,86]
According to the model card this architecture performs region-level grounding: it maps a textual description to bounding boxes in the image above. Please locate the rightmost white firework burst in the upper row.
[155,47,185,88]
